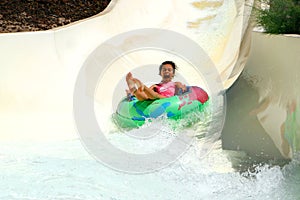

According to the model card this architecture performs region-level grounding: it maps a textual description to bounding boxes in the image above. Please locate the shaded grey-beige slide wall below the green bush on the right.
[222,32,300,158]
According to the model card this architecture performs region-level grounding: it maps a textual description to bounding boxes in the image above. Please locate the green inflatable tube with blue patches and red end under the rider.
[114,86,209,128]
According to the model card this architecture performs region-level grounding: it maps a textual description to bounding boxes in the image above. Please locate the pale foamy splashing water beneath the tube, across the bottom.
[0,94,300,200]
